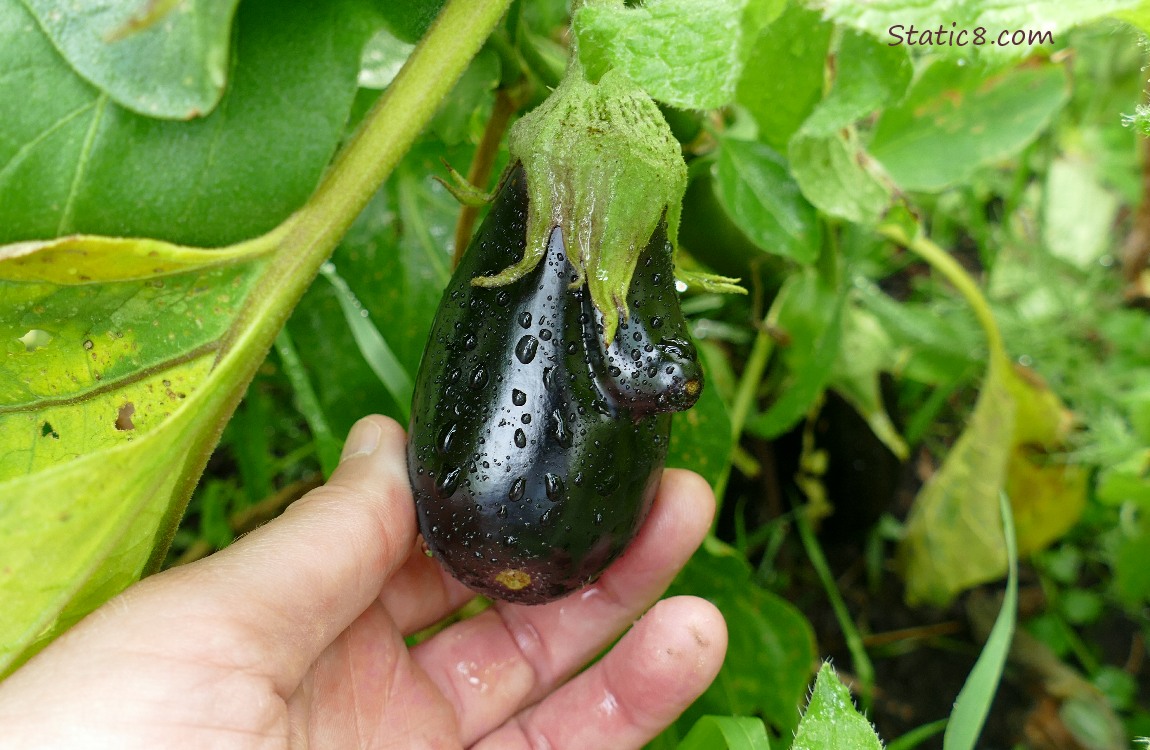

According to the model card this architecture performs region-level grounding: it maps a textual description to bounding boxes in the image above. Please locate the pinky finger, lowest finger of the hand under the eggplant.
[473,597,727,750]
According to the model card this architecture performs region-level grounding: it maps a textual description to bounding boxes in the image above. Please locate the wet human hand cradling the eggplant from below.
[0,416,727,750]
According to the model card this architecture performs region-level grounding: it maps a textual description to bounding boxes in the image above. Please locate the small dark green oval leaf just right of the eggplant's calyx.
[714,138,822,263]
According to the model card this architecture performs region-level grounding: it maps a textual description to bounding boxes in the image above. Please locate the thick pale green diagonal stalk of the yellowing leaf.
[145,0,511,572]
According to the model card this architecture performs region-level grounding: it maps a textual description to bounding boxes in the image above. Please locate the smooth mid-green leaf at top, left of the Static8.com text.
[736,2,834,151]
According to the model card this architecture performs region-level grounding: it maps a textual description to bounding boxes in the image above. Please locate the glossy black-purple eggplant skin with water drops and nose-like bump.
[407,167,702,604]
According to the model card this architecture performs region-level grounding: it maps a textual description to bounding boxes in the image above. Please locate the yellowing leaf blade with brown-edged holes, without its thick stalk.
[0,237,267,671]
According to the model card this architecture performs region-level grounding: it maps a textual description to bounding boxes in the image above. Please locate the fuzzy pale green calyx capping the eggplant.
[472,62,687,343]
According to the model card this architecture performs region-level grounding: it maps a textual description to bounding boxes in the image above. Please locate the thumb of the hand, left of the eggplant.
[142,415,415,690]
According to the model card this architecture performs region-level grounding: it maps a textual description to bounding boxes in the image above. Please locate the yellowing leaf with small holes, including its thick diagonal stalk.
[0,0,517,672]
